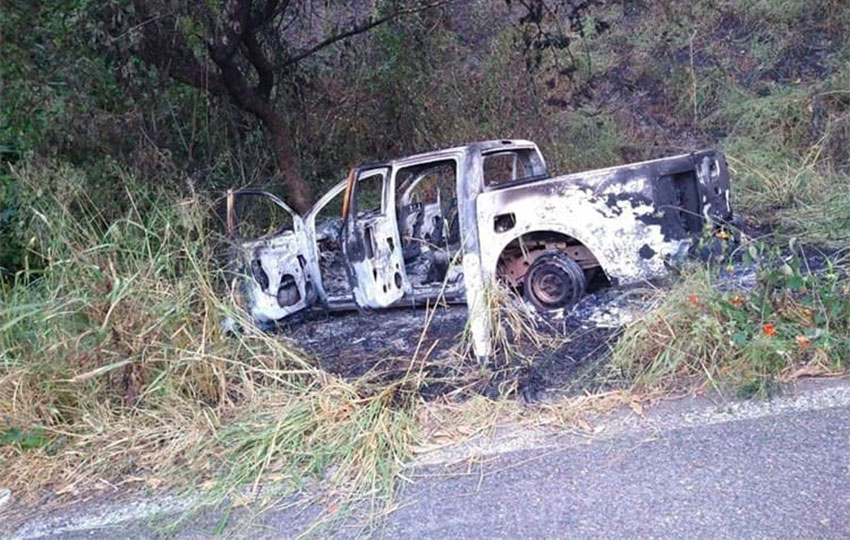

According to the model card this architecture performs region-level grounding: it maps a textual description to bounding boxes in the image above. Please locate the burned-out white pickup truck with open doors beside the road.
[227,140,732,357]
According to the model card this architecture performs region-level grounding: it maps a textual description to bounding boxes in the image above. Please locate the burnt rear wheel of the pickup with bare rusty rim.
[523,251,587,311]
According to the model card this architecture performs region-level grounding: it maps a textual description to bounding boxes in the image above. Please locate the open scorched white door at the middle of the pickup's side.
[342,167,408,308]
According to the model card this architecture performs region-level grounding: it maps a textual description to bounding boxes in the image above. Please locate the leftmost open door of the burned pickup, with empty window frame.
[227,188,317,322]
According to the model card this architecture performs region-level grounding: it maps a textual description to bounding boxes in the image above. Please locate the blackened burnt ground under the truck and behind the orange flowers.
[276,231,844,401]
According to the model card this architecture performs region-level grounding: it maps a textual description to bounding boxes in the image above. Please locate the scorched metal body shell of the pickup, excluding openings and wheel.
[228,140,732,357]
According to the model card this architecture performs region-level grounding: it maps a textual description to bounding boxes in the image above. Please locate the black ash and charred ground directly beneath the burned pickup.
[279,287,664,400]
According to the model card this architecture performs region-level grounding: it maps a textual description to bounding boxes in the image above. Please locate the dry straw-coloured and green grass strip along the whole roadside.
[0,152,847,536]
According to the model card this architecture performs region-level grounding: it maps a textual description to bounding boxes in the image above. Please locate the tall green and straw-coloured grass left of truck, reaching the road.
[0,163,416,516]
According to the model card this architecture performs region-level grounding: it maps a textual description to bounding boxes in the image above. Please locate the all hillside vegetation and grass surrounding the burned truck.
[0,0,850,516]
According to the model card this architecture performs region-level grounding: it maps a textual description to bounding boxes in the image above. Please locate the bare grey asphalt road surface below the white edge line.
[382,407,850,539]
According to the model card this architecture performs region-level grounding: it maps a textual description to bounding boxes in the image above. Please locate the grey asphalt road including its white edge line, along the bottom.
[13,382,850,540]
